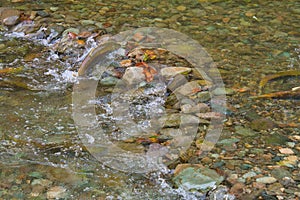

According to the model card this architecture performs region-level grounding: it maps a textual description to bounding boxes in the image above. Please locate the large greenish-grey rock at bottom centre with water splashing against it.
[173,164,224,192]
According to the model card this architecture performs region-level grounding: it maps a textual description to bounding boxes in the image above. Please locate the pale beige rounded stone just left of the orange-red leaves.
[122,67,146,85]
